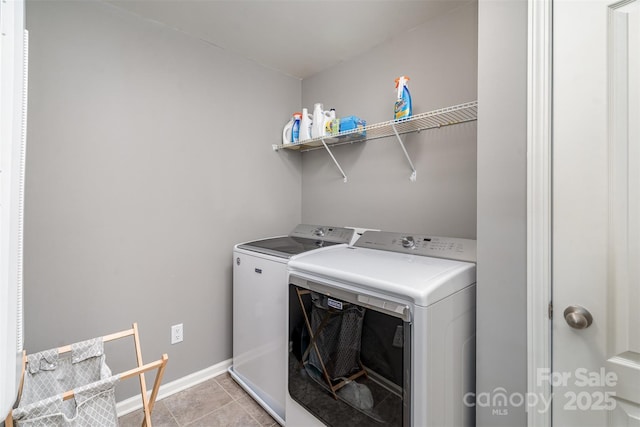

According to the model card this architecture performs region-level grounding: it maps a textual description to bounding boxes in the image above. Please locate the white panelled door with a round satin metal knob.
[552,0,640,427]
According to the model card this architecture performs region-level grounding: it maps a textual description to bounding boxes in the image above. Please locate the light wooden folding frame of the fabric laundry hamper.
[5,323,169,427]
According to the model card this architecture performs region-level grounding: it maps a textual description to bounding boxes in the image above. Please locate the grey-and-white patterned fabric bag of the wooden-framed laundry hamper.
[13,338,119,427]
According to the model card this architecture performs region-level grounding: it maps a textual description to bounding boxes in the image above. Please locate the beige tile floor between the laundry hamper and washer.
[119,373,278,427]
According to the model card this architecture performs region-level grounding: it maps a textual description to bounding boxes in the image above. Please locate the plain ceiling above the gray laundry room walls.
[104,0,474,79]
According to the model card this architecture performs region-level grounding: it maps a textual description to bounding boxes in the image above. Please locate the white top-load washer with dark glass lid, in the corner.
[229,224,355,425]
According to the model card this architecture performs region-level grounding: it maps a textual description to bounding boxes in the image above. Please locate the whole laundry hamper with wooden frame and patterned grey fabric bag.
[5,323,169,427]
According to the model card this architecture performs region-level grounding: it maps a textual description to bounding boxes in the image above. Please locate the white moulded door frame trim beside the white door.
[527,0,553,427]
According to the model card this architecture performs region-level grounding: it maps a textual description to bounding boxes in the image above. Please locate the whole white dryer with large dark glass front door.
[286,232,476,427]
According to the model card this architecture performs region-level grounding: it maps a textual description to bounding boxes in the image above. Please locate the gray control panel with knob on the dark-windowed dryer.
[354,231,476,262]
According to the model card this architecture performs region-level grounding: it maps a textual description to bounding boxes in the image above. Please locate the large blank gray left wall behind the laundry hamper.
[25,1,301,399]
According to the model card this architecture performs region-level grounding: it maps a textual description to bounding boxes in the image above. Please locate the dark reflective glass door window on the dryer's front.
[288,283,411,426]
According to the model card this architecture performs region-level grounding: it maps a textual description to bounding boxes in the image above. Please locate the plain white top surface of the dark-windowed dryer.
[288,246,476,307]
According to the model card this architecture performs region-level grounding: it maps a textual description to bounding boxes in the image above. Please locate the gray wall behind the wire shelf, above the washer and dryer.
[302,2,478,238]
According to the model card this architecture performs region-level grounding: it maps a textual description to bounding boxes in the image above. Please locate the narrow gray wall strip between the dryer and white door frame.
[476,0,527,427]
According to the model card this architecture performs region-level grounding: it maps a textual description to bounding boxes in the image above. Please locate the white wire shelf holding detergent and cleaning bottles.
[274,101,478,152]
